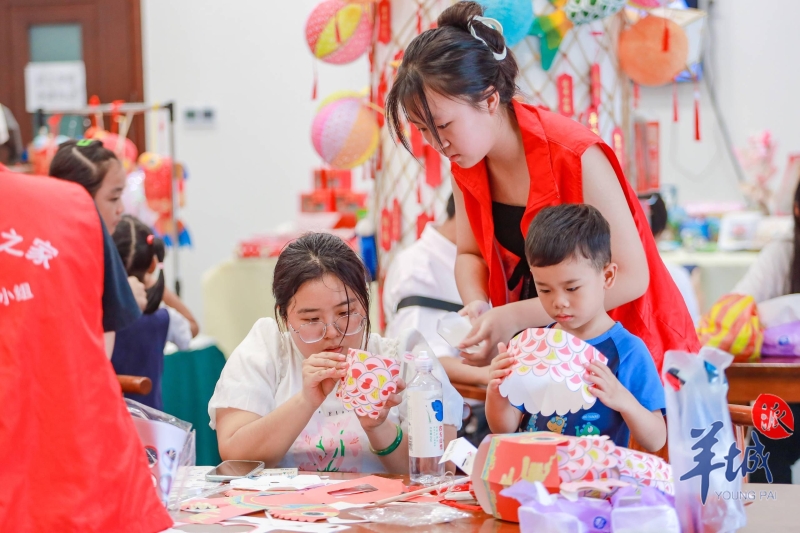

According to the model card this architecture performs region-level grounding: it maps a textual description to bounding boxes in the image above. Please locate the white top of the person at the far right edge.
[731,239,794,303]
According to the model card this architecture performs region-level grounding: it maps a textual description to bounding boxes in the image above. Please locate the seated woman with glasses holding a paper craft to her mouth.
[208,233,463,473]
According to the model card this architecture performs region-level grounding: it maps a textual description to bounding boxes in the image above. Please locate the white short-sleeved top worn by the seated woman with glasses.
[208,318,463,472]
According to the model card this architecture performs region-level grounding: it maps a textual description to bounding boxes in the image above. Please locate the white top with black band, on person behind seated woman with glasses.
[383,223,461,357]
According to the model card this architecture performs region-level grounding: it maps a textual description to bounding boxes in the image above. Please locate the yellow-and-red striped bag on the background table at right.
[697,294,764,361]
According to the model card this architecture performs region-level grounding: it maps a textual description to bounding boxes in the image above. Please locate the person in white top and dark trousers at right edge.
[731,181,800,483]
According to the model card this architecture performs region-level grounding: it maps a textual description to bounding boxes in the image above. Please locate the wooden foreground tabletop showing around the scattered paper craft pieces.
[183,473,800,533]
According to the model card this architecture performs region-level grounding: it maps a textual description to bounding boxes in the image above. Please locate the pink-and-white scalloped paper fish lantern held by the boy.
[500,328,608,416]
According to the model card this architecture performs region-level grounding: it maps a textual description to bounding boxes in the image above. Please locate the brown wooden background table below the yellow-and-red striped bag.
[453,357,800,405]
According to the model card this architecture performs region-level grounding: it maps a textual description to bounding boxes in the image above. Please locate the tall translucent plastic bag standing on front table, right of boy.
[661,348,747,533]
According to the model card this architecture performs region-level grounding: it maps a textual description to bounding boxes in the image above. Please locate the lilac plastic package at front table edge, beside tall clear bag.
[611,487,681,533]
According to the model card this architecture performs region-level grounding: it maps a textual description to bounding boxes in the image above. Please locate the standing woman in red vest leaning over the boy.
[386,2,699,369]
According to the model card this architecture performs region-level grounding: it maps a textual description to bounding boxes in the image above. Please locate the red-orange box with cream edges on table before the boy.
[471,432,568,522]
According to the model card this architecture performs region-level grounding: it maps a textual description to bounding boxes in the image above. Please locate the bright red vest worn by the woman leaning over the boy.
[451,101,700,371]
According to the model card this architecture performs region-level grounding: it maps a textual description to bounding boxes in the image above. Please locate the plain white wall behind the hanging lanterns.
[142,0,800,320]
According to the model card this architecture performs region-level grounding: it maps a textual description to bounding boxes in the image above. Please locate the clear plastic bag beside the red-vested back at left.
[125,398,197,511]
